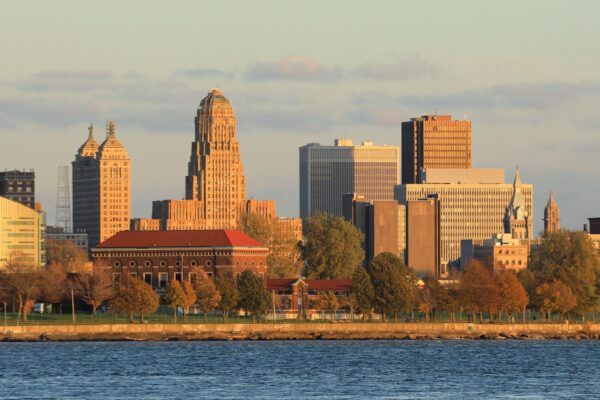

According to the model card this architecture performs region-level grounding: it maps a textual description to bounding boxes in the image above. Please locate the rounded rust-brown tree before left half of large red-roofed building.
[110,277,158,323]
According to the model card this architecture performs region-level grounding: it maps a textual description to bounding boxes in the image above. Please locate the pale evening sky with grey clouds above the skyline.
[0,0,600,230]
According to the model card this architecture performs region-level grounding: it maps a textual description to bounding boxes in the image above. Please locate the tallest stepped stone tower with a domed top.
[185,89,246,229]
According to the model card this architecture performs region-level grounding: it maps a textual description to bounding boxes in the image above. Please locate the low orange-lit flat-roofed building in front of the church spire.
[461,233,529,273]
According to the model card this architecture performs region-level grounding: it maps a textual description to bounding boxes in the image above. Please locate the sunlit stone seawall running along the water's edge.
[0,322,600,341]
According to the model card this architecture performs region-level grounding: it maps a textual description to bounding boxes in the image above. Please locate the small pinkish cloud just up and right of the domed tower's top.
[246,56,342,81]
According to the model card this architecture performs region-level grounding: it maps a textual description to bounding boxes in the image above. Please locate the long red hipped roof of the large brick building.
[96,229,265,249]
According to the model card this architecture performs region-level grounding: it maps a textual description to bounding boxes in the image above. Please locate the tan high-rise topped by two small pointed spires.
[72,121,131,248]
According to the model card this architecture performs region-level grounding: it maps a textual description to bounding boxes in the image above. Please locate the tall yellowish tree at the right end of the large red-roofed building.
[240,213,302,278]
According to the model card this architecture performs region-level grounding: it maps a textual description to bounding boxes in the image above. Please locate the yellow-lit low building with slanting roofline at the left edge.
[0,197,46,269]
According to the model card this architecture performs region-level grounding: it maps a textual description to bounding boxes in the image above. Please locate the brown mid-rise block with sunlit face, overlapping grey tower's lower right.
[343,193,406,265]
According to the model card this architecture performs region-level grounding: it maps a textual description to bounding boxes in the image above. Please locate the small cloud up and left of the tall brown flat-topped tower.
[355,56,442,81]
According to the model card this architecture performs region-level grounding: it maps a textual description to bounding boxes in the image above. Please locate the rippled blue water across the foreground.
[0,340,600,400]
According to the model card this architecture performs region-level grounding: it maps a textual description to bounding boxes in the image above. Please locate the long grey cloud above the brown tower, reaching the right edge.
[398,81,600,111]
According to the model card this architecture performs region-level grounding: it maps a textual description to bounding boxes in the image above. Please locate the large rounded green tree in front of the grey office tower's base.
[299,214,365,279]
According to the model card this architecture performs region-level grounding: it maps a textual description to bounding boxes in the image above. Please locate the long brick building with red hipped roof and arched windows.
[92,229,269,289]
